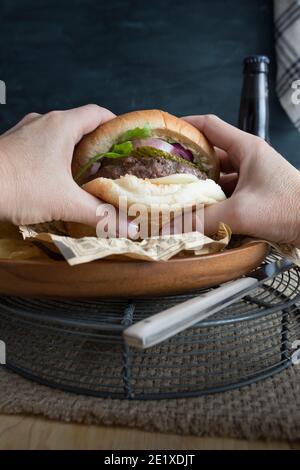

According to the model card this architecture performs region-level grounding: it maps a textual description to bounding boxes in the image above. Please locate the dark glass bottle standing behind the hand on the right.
[238,55,270,142]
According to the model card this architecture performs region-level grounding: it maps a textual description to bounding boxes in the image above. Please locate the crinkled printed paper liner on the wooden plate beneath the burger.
[20,223,300,266]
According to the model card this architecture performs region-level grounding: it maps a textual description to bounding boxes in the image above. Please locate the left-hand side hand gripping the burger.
[0,105,136,236]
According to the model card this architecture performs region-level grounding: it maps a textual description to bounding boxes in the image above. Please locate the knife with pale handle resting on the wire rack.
[123,259,293,349]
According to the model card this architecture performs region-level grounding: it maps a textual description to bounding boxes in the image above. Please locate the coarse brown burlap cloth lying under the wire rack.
[0,366,300,441]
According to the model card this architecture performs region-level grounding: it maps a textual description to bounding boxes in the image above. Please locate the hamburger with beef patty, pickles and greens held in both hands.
[68,110,225,236]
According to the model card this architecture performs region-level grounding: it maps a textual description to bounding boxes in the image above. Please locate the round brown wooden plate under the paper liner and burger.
[0,242,268,298]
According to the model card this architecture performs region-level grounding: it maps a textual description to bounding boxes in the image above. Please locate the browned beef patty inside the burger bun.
[93,156,207,180]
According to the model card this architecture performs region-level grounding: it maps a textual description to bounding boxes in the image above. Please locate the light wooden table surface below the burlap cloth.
[0,415,300,450]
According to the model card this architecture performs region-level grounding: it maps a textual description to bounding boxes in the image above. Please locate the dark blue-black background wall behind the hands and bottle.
[0,0,300,167]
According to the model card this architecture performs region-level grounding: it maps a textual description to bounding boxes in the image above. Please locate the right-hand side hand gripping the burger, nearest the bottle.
[184,115,300,247]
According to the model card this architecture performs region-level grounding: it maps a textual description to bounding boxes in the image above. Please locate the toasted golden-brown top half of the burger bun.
[72,109,220,181]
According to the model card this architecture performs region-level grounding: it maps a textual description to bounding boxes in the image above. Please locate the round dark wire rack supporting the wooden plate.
[0,254,300,400]
